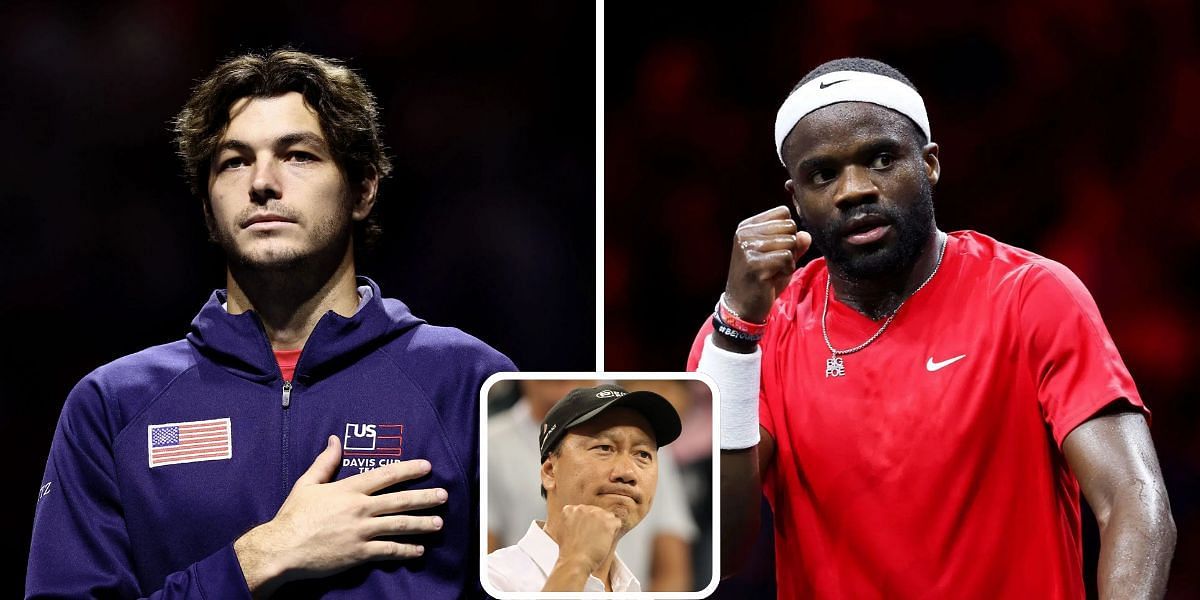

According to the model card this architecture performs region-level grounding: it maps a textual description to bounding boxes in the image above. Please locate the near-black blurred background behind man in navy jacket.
[0,0,596,598]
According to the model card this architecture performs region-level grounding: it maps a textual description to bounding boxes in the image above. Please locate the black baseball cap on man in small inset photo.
[538,384,683,462]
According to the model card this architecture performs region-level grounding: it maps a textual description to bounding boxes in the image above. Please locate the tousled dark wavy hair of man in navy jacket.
[174,48,391,247]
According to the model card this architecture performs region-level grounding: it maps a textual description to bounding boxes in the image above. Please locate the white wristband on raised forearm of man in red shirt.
[696,335,762,450]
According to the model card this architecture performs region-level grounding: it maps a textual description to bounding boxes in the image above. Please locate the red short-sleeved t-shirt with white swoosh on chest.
[689,232,1148,599]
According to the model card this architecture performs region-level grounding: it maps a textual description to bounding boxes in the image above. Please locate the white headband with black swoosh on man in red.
[775,71,934,162]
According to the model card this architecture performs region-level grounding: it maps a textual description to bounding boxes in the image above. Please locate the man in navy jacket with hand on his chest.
[25,50,515,600]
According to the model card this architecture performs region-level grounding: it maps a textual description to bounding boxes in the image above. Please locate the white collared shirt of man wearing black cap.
[487,521,642,592]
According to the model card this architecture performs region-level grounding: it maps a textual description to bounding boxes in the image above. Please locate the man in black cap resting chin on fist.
[487,385,682,592]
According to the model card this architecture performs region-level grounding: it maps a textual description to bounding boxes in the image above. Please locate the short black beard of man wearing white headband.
[809,178,936,280]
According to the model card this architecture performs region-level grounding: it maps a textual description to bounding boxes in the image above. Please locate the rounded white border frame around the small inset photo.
[478,371,721,600]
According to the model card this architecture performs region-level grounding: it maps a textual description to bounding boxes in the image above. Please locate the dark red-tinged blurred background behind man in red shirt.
[604,0,1200,598]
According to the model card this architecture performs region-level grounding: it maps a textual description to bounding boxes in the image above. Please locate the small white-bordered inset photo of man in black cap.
[480,373,720,600]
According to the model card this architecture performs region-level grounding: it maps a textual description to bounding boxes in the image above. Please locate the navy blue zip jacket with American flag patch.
[25,277,516,600]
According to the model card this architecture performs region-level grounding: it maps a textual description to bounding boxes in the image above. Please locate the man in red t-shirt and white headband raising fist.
[689,59,1175,599]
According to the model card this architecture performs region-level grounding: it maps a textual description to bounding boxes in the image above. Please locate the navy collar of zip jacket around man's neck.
[180,276,425,382]
